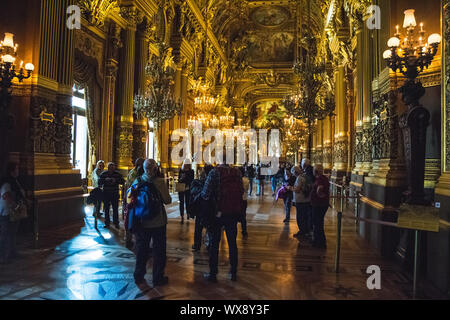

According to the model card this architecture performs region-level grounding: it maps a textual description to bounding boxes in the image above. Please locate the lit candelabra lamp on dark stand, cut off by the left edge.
[0,33,34,172]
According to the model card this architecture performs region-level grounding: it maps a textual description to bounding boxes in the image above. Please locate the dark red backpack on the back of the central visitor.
[217,167,244,217]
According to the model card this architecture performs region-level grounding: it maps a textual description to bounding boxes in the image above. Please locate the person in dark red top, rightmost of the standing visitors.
[311,165,330,249]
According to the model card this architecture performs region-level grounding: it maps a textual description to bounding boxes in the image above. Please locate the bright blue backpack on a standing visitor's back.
[130,179,162,220]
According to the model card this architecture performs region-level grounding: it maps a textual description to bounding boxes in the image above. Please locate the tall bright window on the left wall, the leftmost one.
[72,84,89,179]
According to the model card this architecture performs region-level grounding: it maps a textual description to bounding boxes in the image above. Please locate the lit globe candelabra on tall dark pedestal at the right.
[383,9,441,205]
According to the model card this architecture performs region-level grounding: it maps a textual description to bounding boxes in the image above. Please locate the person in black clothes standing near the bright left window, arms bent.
[98,162,125,229]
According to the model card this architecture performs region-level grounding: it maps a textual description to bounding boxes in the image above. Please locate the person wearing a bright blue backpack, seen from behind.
[128,159,172,287]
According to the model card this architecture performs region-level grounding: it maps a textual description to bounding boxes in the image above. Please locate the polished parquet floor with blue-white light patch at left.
[0,188,444,300]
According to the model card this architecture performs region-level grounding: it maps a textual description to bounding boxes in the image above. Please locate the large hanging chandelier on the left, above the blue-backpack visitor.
[134,43,183,126]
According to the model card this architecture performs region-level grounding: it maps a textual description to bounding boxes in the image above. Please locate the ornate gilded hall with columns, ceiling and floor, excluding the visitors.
[0,0,450,300]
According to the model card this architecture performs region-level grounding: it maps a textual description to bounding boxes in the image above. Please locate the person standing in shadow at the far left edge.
[0,163,27,264]
